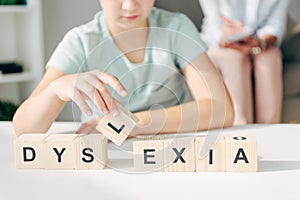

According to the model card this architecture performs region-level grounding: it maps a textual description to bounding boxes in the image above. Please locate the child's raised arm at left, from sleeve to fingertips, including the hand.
[13,67,127,135]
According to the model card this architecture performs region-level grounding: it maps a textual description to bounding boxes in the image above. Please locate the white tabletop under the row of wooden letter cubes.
[0,122,300,200]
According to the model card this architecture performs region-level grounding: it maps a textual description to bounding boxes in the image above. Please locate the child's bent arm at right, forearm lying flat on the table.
[132,53,234,135]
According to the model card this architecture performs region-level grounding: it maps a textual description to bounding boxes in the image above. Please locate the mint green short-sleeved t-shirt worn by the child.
[46,8,207,121]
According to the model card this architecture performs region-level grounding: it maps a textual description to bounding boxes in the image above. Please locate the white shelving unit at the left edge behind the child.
[0,0,43,104]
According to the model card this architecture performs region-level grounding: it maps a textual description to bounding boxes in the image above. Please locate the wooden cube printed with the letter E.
[133,135,165,172]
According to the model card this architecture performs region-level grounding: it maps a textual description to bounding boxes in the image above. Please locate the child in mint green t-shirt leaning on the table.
[13,0,233,136]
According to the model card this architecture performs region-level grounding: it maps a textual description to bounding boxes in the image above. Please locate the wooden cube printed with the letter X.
[164,135,195,172]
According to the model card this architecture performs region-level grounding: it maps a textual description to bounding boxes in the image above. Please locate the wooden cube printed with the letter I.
[195,136,226,172]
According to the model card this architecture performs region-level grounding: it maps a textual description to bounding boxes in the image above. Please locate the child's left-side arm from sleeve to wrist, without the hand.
[13,67,64,135]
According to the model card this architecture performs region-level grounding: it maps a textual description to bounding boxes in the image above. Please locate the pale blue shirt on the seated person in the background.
[199,0,290,46]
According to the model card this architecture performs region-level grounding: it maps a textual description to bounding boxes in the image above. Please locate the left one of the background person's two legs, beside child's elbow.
[208,48,253,125]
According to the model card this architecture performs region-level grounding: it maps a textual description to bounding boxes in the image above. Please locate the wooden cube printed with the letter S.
[76,134,108,170]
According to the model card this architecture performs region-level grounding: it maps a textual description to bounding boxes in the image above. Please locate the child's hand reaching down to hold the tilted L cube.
[50,70,127,116]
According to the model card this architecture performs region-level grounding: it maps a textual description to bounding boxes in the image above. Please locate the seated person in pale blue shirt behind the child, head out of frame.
[199,0,289,124]
